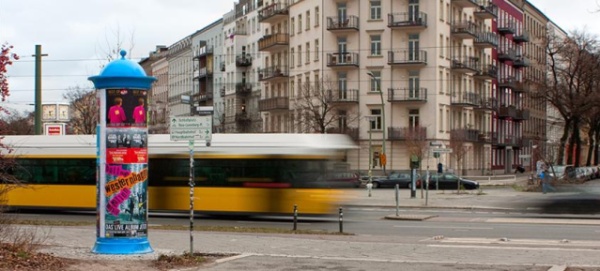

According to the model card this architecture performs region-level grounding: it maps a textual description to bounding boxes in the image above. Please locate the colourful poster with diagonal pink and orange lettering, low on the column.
[104,163,148,237]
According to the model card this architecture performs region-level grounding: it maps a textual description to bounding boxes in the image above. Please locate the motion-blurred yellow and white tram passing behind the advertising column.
[2,134,356,215]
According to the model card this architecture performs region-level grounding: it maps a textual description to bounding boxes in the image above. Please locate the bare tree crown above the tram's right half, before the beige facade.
[292,81,360,134]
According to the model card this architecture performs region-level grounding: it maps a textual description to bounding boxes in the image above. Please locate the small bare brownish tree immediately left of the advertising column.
[63,87,100,135]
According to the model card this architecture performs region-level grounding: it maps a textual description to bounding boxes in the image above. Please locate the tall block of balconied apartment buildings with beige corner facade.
[145,0,572,174]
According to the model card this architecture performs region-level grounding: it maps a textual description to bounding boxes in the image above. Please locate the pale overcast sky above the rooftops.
[0,0,600,113]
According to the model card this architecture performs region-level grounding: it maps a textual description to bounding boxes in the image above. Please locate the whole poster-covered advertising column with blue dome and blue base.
[89,51,155,254]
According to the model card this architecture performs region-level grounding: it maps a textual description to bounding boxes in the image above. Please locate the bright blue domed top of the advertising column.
[88,50,156,89]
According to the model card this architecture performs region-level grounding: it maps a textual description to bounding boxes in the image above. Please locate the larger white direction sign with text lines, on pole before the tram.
[170,116,212,141]
